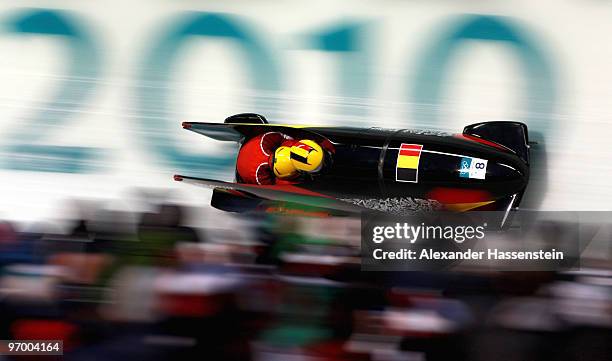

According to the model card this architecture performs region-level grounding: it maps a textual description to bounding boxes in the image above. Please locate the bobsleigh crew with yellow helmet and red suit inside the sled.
[236,132,333,185]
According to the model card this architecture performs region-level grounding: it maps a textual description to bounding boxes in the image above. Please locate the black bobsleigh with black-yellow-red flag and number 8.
[174,114,529,225]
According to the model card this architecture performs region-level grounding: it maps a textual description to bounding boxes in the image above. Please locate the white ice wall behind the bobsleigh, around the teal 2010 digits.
[0,0,612,224]
